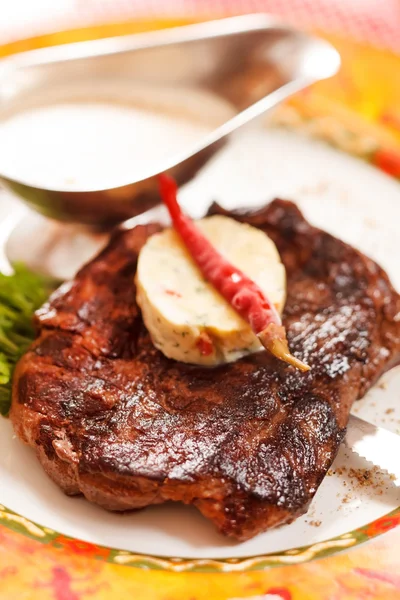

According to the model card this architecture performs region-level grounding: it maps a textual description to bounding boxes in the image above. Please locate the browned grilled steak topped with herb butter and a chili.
[11,200,400,540]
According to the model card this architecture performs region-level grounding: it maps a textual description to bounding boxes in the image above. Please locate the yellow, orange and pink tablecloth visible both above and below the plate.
[0,0,400,600]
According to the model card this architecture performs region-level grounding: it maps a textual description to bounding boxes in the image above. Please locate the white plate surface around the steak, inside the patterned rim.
[0,127,400,558]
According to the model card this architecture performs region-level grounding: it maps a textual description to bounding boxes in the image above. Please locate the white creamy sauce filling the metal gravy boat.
[0,102,216,190]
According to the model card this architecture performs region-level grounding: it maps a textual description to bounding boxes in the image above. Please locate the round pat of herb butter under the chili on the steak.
[136,216,286,366]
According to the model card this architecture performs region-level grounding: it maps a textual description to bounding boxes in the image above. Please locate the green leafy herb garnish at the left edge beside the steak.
[0,265,55,415]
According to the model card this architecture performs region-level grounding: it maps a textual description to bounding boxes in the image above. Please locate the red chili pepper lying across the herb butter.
[159,174,310,371]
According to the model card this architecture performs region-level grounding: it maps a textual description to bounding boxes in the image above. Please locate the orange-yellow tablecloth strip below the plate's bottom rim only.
[0,527,400,600]
